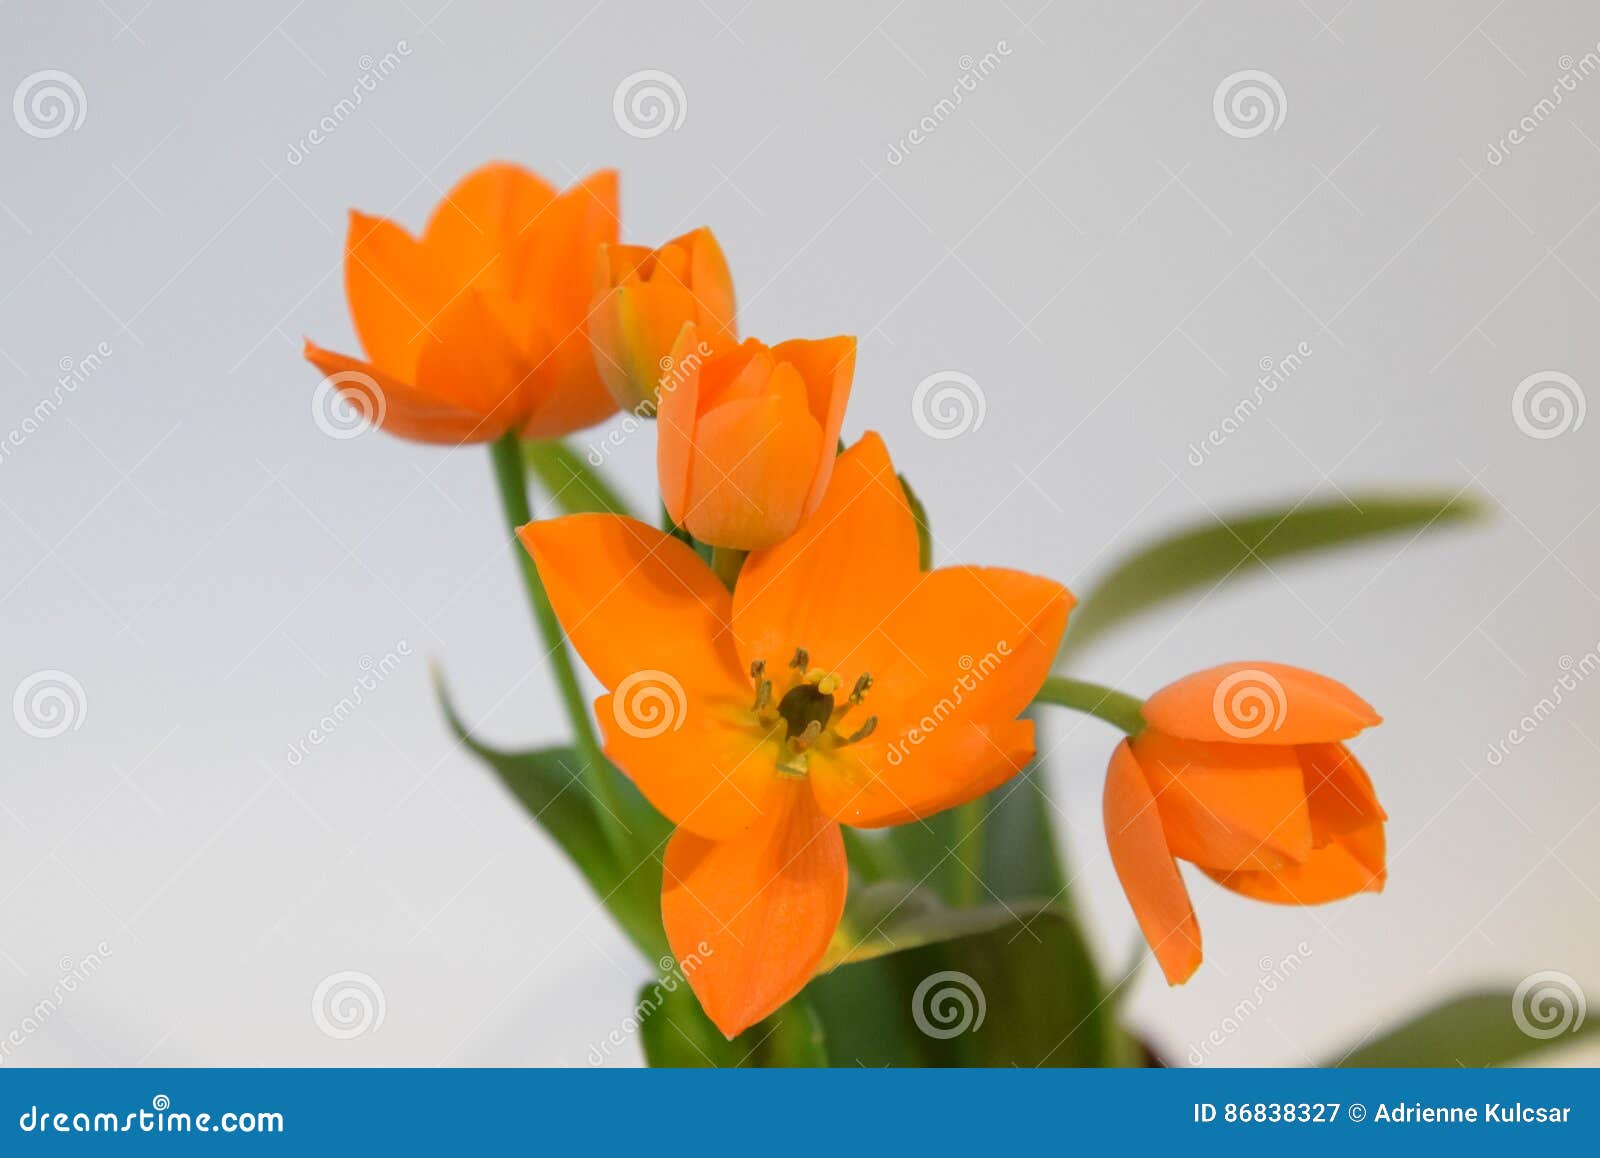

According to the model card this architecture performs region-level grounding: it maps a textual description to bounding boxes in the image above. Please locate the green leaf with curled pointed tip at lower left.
[434,672,670,958]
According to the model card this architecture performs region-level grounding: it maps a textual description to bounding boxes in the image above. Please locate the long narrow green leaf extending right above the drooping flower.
[1066,493,1478,648]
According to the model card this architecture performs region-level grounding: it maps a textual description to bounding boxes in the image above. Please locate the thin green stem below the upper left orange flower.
[490,432,626,854]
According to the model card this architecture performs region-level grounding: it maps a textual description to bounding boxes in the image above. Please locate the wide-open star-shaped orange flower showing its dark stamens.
[522,433,1072,1036]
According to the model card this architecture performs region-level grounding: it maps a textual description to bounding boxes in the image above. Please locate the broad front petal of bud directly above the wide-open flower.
[683,366,824,550]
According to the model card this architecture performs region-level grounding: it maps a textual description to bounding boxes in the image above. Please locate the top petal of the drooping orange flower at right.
[1144,661,1382,744]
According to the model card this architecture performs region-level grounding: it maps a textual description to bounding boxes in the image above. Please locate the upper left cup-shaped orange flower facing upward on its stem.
[306,162,618,443]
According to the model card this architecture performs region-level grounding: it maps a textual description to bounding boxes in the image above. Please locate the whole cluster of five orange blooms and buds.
[306,163,1386,1036]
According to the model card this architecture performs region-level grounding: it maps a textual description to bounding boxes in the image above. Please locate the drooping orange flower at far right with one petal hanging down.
[1104,662,1387,985]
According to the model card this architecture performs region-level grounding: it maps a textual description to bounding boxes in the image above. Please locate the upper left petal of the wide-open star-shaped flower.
[517,515,749,696]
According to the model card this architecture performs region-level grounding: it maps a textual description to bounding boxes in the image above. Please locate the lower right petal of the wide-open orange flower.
[808,720,1034,829]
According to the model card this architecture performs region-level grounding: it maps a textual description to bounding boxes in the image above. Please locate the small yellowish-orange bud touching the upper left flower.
[589,229,739,409]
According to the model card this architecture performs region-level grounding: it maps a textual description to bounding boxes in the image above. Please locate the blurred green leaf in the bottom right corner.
[1330,992,1600,1067]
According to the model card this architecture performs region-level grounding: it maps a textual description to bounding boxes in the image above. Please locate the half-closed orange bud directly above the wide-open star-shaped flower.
[656,325,856,550]
